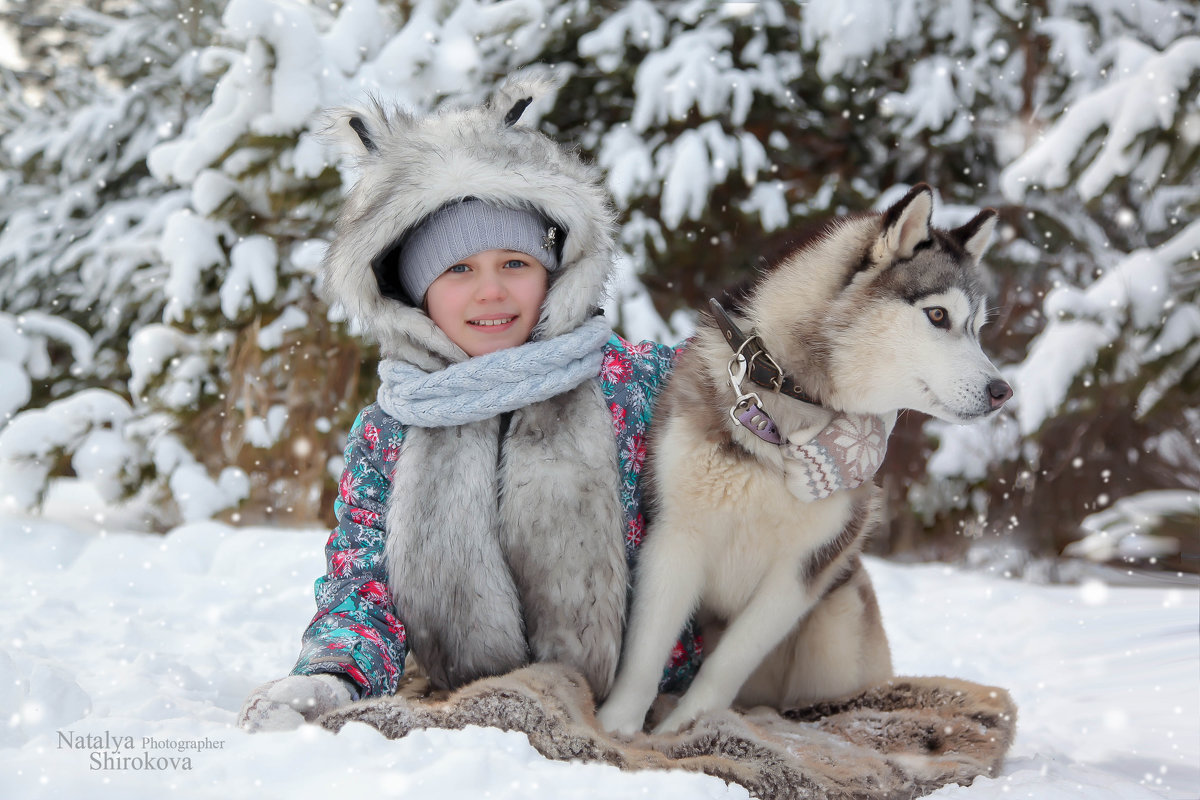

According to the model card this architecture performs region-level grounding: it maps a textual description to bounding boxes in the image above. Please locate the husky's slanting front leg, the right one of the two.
[654,567,814,734]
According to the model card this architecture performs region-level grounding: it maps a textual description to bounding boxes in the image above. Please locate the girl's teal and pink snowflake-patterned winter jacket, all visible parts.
[292,335,702,697]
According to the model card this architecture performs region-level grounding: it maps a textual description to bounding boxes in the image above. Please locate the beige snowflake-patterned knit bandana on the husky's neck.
[782,414,895,503]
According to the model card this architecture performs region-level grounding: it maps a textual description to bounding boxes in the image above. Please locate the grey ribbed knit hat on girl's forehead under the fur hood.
[396,198,563,305]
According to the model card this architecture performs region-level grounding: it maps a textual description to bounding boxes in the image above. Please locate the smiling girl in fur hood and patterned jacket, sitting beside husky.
[240,80,698,729]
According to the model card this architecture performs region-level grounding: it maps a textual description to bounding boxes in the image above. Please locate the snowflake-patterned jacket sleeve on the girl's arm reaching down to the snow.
[292,405,407,697]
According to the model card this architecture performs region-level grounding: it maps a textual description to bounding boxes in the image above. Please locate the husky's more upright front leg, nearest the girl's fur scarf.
[596,532,704,736]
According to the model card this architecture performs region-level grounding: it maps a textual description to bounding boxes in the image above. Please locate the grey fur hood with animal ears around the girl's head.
[323,77,616,367]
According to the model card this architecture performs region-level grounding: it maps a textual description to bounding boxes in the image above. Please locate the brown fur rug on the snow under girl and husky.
[318,663,1016,800]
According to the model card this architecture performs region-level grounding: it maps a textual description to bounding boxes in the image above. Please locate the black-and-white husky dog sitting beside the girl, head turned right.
[598,184,1012,735]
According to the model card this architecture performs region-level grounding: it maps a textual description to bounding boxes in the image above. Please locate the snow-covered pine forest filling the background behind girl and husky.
[0,0,1200,578]
